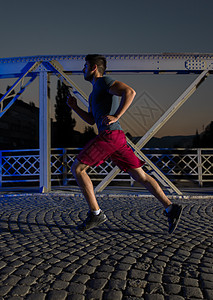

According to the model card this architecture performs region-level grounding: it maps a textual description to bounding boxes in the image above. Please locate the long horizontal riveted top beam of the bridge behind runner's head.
[0,53,213,78]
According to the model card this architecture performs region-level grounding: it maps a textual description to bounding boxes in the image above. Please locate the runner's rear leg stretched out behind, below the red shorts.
[128,168,182,233]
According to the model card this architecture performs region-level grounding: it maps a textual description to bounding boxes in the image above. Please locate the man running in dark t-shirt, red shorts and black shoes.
[67,54,182,233]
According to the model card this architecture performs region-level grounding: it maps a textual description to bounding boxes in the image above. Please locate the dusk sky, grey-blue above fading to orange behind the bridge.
[0,0,213,136]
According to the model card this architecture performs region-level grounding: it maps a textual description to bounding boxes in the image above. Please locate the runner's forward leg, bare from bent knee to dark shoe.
[72,159,107,231]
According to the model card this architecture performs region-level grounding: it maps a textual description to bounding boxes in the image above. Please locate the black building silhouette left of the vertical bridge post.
[0,95,39,150]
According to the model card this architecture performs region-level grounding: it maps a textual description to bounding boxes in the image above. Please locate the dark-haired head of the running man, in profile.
[83,54,106,81]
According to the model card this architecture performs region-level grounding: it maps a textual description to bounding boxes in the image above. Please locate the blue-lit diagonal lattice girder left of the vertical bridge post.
[0,62,41,118]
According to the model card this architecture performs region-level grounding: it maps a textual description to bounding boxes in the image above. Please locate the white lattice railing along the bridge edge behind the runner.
[0,148,213,187]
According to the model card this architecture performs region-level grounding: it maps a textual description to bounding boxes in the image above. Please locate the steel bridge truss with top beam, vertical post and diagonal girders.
[0,53,213,195]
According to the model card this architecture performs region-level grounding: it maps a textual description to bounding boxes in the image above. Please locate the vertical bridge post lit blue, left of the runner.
[39,70,51,193]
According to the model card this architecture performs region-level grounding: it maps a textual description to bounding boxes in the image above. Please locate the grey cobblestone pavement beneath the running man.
[0,193,213,300]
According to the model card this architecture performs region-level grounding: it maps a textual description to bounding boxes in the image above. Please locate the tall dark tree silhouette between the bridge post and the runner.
[54,80,76,147]
